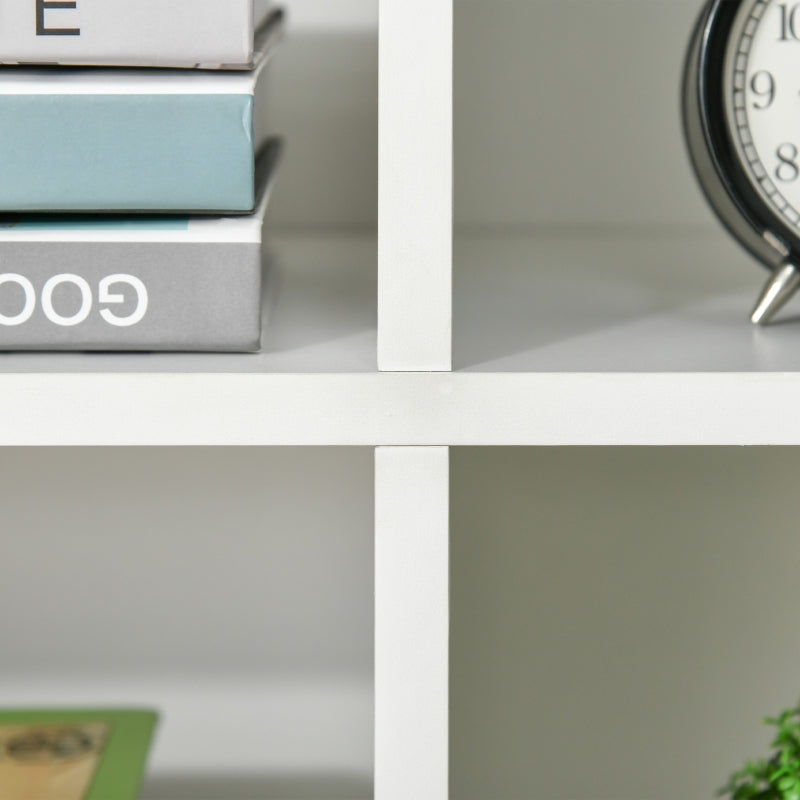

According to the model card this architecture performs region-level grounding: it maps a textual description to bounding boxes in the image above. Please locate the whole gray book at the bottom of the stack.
[0,143,279,352]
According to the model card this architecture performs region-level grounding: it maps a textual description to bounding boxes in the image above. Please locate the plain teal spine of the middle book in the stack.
[0,92,255,213]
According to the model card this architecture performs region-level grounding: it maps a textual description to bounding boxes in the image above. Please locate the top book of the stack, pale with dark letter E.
[0,0,273,69]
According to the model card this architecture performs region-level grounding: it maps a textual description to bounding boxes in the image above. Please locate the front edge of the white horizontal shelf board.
[7,373,800,447]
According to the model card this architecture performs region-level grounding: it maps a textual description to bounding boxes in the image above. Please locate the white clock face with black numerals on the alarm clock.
[724,0,800,236]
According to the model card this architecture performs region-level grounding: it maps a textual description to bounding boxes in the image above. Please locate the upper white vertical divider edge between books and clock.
[378,0,453,372]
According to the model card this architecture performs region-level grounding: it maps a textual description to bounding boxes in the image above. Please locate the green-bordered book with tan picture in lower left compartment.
[0,709,157,800]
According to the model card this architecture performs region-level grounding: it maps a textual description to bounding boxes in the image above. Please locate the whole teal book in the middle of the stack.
[0,13,281,213]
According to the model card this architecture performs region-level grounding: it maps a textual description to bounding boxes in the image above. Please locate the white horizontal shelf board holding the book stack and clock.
[0,231,800,446]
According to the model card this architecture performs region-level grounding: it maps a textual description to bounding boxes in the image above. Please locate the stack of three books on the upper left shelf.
[0,0,282,352]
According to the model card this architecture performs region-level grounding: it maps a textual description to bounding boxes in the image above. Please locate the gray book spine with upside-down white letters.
[0,241,262,352]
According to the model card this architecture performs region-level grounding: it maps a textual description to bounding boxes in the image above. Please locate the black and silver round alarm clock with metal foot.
[683,0,800,325]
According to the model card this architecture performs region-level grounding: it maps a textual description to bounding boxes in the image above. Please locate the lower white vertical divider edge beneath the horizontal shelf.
[375,447,450,800]
